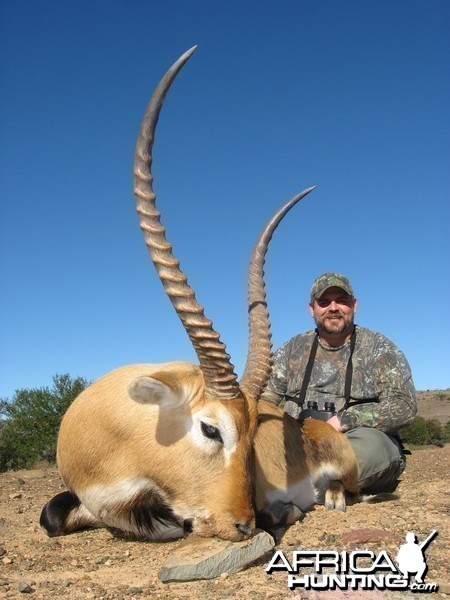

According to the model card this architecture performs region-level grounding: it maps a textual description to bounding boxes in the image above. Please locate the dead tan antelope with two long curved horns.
[41,47,357,540]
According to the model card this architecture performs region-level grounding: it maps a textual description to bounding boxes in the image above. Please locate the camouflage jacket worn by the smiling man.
[262,325,417,433]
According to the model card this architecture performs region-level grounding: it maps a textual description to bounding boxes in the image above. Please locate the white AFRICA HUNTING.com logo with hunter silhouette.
[266,529,438,592]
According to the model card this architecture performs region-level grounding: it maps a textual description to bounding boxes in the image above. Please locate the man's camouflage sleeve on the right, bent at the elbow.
[339,335,417,433]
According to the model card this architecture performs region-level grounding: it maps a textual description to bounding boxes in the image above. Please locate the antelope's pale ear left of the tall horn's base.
[128,375,189,409]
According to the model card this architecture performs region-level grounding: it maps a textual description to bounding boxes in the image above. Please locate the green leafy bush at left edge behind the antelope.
[0,375,88,471]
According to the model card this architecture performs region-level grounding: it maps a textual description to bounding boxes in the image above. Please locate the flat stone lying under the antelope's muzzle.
[158,531,275,582]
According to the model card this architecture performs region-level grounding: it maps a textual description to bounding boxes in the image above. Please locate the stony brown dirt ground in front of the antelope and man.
[0,445,450,600]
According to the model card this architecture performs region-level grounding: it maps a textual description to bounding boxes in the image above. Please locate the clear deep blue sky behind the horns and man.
[0,0,450,398]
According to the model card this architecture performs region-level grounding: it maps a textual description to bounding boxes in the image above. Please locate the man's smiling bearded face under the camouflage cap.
[309,287,356,335]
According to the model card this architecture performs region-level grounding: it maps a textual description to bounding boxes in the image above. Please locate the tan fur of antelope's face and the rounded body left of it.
[57,362,256,539]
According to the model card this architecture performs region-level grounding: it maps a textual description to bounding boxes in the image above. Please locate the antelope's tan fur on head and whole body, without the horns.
[52,362,357,540]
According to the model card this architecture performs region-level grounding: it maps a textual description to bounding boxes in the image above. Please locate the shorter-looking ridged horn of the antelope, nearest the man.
[240,186,315,400]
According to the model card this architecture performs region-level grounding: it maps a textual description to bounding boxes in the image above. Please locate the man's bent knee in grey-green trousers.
[345,427,405,493]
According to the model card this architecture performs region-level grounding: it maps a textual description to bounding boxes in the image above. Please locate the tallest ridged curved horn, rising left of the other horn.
[134,46,240,399]
